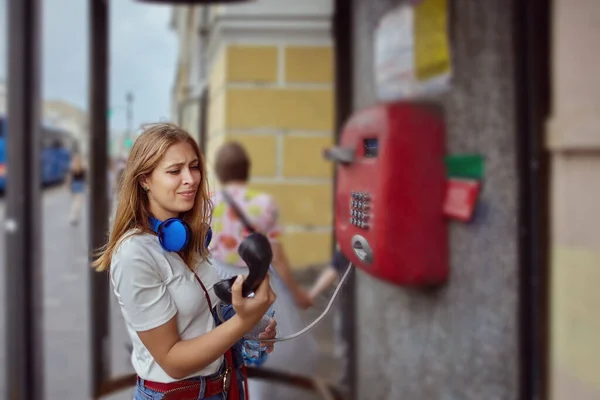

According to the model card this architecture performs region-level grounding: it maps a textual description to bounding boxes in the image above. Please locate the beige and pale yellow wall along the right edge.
[548,0,600,400]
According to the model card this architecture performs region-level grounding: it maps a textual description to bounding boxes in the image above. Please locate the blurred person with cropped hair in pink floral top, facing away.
[211,141,319,400]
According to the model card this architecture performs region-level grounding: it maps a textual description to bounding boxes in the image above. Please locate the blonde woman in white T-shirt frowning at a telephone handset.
[94,124,275,400]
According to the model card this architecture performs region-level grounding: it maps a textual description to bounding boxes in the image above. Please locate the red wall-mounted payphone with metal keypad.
[325,103,449,286]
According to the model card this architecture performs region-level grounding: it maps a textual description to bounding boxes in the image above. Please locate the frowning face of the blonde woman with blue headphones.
[142,142,202,221]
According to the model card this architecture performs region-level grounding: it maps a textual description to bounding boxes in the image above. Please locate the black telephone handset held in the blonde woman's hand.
[214,232,273,305]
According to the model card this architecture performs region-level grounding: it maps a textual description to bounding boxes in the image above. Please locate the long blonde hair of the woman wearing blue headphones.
[92,123,212,271]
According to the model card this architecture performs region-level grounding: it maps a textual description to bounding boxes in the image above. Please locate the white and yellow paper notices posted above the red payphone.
[374,0,451,101]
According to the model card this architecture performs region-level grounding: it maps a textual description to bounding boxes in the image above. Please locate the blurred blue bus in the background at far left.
[0,116,74,191]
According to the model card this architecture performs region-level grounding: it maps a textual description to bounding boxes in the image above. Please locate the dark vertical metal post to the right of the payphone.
[511,0,552,400]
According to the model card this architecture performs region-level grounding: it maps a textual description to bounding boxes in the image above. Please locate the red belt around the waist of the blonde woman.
[138,363,235,400]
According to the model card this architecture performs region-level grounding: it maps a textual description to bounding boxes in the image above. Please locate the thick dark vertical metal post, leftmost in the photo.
[4,0,44,400]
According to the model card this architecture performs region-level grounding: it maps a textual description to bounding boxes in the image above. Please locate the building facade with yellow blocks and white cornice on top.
[173,0,335,268]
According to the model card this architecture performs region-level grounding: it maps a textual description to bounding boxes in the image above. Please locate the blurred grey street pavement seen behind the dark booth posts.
[0,187,336,400]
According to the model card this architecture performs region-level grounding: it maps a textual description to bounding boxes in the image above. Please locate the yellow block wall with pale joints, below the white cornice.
[207,43,335,268]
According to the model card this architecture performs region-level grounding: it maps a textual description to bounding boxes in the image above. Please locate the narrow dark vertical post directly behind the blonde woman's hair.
[89,0,110,398]
